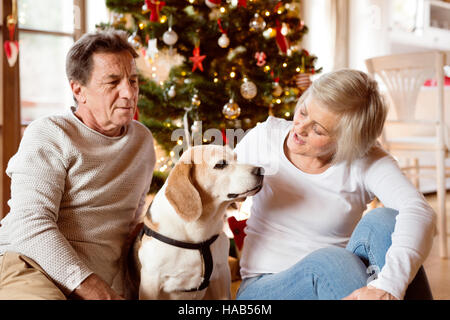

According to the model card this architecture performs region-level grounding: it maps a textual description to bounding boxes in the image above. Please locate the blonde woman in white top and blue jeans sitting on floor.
[235,69,435,299]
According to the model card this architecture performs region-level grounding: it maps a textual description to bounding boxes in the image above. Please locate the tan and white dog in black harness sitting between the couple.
[135,145,263,300]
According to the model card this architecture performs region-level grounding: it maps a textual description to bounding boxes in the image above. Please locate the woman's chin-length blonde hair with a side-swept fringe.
[297,69,387,163]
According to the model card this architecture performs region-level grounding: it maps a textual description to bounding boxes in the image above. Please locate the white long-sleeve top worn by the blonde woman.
[235,117,436,299]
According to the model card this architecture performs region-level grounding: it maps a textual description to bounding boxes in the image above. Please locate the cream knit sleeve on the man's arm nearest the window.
[3,123,92,295]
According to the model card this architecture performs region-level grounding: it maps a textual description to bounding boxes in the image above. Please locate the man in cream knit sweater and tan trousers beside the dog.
[0,30,155,299]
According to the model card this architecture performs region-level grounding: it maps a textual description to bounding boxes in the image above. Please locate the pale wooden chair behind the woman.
[366,51,450,258]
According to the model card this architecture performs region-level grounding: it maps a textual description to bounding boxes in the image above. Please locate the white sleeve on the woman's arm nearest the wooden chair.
[364,150,436,299]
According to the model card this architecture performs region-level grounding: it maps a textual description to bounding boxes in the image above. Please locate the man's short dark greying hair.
[66,29,138,85]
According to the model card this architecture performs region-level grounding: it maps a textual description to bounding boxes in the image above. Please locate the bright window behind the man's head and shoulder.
[18,0,108,125]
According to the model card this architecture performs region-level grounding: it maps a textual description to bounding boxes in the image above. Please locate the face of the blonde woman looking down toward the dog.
[287,95,338,158]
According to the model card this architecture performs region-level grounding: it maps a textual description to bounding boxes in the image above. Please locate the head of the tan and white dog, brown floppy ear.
[165,145,263,222]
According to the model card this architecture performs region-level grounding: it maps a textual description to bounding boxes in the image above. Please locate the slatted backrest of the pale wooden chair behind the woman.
[366,51,450,146]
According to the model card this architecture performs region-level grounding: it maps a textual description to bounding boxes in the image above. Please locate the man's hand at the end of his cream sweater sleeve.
[69,273,124,300]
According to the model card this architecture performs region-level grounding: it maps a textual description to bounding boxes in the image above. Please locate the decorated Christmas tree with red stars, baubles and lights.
[101,0,320,188]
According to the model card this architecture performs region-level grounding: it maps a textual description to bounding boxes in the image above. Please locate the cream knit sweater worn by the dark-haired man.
[0,108,155,294]
